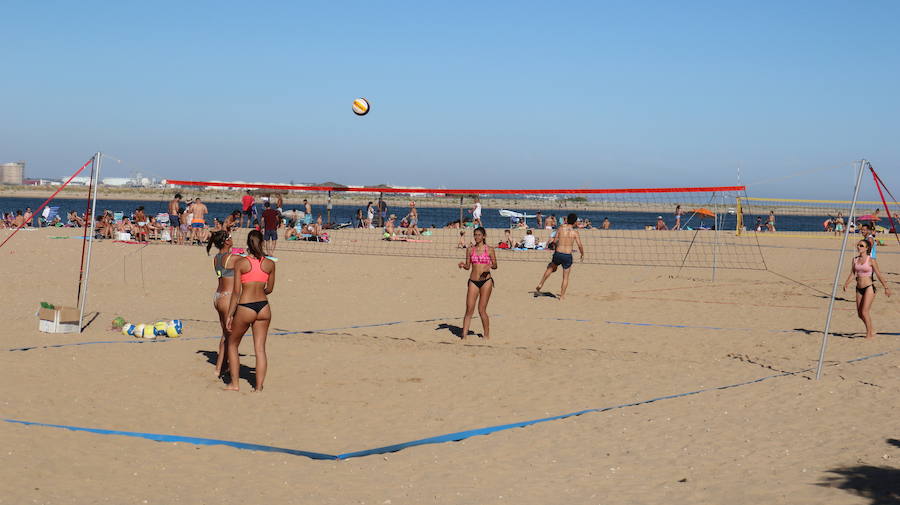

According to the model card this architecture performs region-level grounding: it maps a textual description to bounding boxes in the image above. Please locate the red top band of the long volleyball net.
[163,179,746,195]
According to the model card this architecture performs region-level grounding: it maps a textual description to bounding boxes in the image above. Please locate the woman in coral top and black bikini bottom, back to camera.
[225,230,275,391]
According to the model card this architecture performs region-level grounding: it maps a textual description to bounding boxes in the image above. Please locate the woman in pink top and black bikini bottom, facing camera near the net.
[458,226,497,340]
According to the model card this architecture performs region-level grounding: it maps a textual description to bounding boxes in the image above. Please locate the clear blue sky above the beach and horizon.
[0,1,900,198]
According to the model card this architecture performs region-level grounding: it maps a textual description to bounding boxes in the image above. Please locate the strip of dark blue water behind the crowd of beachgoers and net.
[0,197,840,231]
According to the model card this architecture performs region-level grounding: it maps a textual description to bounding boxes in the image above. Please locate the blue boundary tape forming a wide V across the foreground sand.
[3,348,900,460]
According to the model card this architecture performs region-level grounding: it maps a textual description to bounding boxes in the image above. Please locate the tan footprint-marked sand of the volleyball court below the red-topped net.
[0,230,900,504]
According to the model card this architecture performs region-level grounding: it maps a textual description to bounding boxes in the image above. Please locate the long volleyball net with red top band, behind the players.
[166,180,765,269]
